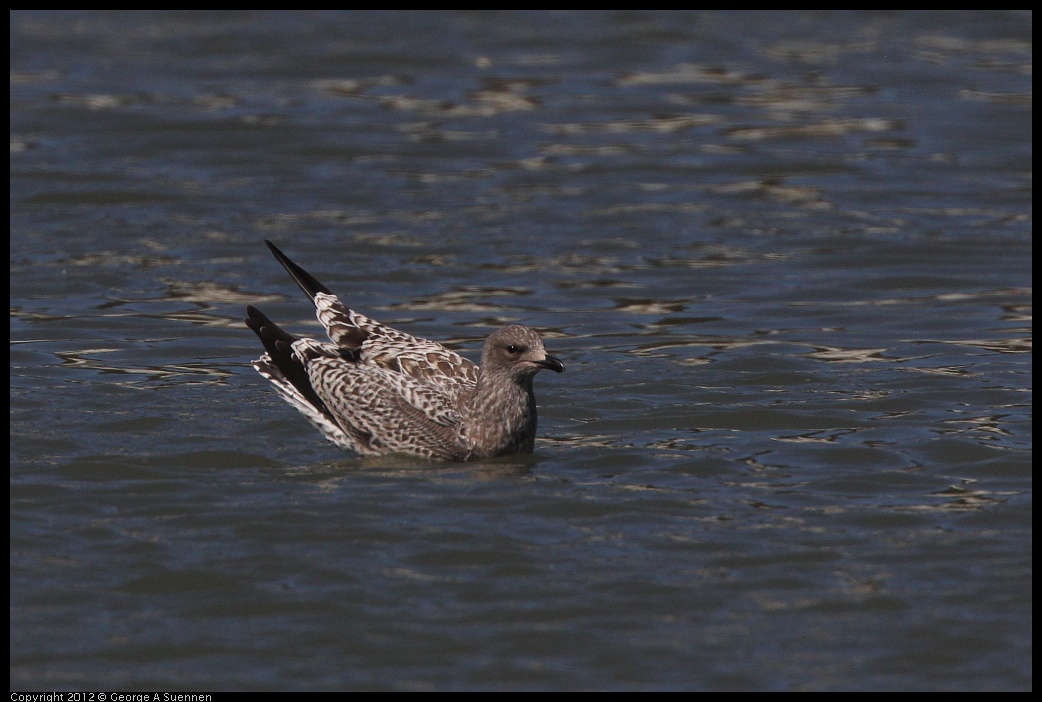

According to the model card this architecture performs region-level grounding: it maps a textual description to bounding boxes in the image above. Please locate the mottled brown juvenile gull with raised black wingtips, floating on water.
[246,241,565,460]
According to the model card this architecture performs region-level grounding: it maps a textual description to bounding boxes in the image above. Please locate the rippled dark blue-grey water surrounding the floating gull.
[10,11,1032,692]
